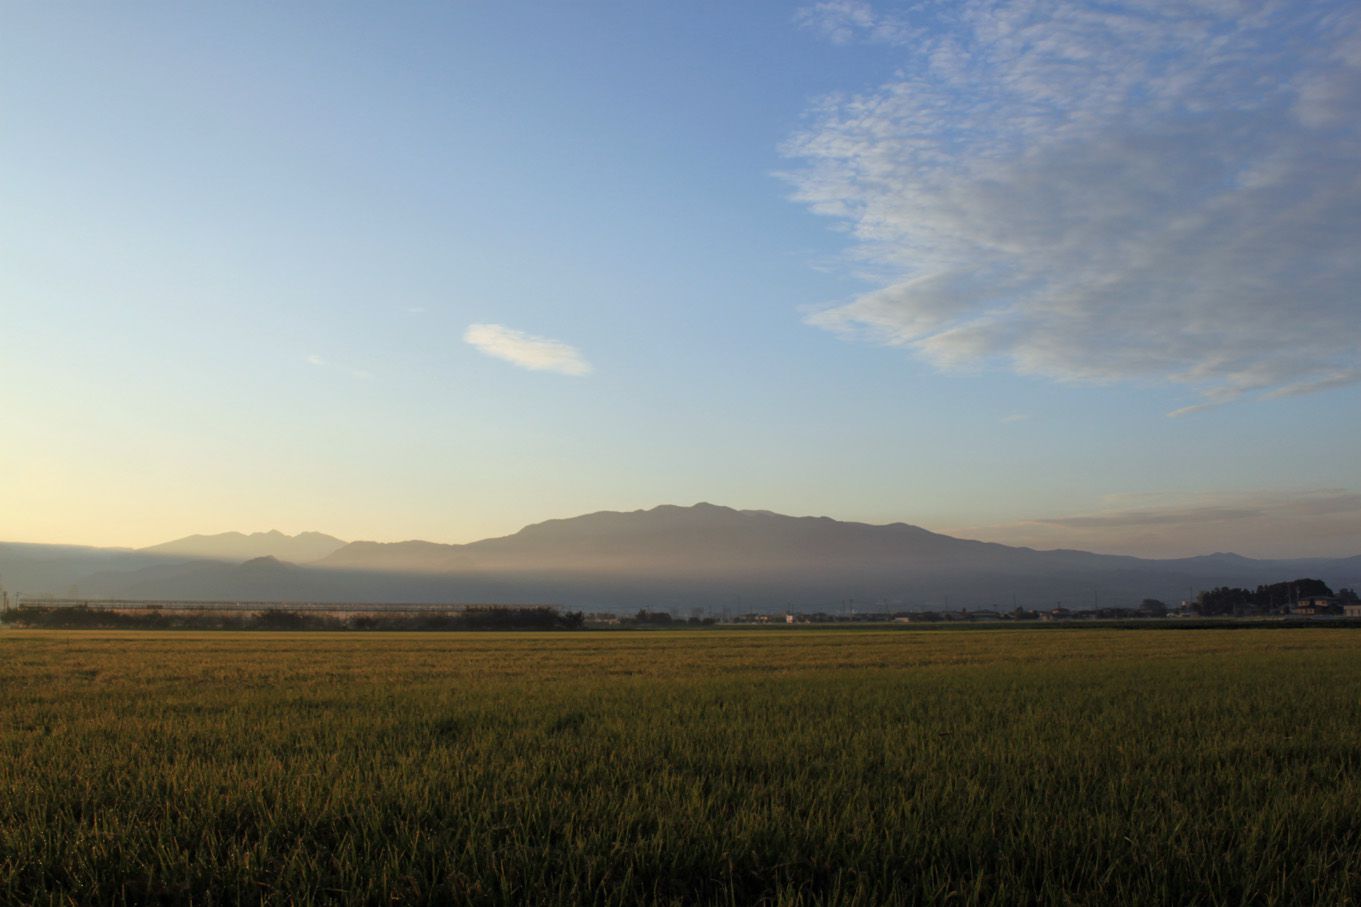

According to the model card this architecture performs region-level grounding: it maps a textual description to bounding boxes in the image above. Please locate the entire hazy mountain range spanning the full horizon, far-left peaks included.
[0,504,1361,610]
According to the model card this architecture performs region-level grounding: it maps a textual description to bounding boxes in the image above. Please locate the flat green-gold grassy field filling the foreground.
[0,629,1361,904]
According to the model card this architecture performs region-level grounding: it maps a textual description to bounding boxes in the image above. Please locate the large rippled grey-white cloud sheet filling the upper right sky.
[784,0,1361,415]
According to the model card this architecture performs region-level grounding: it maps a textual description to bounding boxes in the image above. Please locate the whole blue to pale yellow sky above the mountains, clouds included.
[0,0,1361,557]
